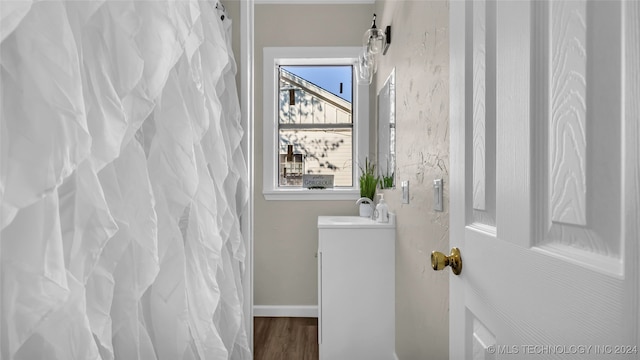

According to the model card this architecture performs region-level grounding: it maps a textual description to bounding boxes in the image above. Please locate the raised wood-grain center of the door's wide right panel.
[543,1,591,226]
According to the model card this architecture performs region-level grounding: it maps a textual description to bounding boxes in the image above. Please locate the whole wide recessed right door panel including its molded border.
[536,1,623,274]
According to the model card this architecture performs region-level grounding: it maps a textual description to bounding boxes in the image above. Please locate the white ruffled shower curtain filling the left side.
[0,0,251,360]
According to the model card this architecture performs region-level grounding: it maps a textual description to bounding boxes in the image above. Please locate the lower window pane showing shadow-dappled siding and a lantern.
[279,128,353,187]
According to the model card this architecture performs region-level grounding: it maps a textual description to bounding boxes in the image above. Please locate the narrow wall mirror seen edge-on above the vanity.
[378,68,396,189]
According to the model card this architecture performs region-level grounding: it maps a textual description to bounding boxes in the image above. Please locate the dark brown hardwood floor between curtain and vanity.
[253,317,318,360]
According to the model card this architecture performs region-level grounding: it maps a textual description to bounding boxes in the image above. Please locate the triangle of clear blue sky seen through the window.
[282,66,353,102]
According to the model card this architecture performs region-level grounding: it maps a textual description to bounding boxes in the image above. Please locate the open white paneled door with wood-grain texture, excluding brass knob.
[448,0,640,359]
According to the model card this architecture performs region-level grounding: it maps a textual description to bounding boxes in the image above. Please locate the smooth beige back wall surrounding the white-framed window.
[254,4,373,306]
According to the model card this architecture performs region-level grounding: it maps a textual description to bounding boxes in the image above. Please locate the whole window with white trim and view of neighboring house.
[263,47,369,200]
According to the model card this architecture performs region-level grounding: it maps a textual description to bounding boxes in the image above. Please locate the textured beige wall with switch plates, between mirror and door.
[376,0,449,360]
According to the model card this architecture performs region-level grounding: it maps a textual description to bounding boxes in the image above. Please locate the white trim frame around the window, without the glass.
[262,47,369,200]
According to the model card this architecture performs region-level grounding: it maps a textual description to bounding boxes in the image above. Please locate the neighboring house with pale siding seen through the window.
[278,66,353,187]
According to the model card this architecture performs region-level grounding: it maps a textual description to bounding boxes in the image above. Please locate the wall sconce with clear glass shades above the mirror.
[358,14,391,85]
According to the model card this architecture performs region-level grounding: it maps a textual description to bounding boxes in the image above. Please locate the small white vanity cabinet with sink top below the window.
[318,214,395,360]
